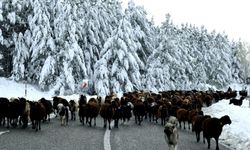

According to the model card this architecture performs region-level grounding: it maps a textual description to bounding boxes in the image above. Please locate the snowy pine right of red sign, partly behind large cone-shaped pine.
[77,0,122,93]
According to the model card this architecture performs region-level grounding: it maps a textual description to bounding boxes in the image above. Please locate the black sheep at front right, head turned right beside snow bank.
[202,115,232,150]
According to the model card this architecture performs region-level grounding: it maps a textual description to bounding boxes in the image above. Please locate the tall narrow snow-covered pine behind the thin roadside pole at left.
[19,0,55,86]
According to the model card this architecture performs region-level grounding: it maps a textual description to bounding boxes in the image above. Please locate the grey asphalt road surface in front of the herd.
[0,117,229,150]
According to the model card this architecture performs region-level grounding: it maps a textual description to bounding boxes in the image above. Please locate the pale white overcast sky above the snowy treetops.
[121,0,250,42]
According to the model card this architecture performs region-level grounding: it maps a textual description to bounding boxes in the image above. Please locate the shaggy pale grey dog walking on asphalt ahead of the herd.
[164,117,179,150]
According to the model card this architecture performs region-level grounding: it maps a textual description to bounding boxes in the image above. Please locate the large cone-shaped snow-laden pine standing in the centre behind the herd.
[94,17,144,95]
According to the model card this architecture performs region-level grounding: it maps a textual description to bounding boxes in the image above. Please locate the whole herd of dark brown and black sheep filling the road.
[0,87,247,150]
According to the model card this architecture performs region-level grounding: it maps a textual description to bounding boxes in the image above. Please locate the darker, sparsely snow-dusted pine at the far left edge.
[0,0,31,77]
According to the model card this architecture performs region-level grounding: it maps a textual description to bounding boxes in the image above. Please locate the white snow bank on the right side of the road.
[202,84,250,150]
